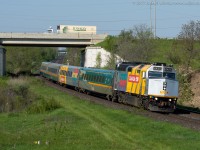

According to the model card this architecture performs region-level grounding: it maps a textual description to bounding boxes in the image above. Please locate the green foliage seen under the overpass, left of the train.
[6,47,56,75]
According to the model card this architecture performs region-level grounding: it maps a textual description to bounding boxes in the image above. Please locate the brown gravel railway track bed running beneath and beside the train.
[38,77,200,131]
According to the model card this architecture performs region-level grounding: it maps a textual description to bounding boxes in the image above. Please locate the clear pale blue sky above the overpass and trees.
[0,0,200,38]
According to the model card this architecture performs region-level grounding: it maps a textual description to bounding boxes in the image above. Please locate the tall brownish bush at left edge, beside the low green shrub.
[0,77,35,112]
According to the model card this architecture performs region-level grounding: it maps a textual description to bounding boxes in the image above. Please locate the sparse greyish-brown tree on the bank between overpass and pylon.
[117,25,154,61]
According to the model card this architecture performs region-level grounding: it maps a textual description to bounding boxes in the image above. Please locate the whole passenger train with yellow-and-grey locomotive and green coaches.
[40,62,178,112]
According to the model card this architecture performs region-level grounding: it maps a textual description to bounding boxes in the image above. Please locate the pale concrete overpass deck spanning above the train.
[0,33,107,47]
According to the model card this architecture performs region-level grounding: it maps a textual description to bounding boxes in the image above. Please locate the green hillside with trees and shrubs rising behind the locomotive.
[99,21,200,72]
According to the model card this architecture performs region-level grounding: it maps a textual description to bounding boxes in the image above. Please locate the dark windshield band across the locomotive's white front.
[148,71,175,80]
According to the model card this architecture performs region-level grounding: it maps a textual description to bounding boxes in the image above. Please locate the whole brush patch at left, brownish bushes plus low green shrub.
[0,77,60,113]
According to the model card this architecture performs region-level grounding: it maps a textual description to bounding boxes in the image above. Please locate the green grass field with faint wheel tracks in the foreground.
[0,79,200,150]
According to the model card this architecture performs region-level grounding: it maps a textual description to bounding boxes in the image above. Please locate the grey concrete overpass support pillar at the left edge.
[0,46,6,77]
